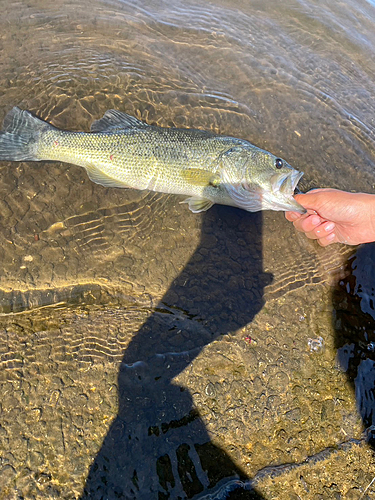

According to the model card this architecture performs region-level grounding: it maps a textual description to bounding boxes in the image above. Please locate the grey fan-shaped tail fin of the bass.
[0,107,54,161]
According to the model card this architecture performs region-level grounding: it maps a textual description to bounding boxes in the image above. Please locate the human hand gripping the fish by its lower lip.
[285,189,375,246]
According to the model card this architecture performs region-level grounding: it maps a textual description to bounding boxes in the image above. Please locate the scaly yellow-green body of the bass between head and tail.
[36,127,238,195]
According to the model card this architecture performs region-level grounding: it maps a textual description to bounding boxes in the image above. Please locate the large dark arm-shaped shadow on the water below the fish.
[82,206,271,500]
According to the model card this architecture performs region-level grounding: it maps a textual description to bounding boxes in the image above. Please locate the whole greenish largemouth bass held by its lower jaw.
[0,107,306,213]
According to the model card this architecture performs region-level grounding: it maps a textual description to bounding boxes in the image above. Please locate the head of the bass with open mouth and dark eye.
[223,144,306,213]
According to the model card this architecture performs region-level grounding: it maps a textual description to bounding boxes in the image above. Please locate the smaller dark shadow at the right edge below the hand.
[333,243,375,449]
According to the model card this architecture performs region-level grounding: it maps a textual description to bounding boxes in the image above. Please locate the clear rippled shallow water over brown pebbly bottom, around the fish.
[0,0,375,500]
